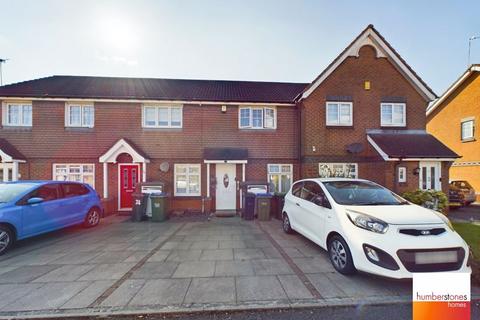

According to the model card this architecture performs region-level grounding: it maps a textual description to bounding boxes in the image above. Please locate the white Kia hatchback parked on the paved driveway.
[283,178,471,279]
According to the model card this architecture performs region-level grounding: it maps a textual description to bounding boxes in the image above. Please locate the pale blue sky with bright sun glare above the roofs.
[0,0,480,94]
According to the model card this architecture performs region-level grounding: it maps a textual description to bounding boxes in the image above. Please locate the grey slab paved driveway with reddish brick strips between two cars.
[0,217,476,317]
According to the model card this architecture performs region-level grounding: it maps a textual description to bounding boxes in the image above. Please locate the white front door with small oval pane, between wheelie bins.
[215,163,237,210]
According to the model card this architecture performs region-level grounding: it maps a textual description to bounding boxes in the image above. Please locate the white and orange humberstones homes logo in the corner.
[412,272,470,320]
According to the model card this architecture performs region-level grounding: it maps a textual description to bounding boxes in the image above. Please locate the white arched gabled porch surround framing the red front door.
[99,138,150,198]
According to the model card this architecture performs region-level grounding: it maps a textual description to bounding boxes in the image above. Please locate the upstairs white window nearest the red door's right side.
[143,106,183,128]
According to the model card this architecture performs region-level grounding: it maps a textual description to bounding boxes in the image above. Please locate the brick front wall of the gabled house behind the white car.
[299,46,432,192]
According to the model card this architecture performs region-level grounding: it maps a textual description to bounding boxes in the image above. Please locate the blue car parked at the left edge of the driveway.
[0,181,103,255]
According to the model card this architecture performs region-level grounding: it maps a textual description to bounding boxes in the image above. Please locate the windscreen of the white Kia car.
[323,181,408,206]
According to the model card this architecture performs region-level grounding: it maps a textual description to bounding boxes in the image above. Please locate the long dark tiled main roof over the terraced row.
[0,76,307,104]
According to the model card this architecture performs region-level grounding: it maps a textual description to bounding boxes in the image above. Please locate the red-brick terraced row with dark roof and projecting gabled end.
[0,25,458,210]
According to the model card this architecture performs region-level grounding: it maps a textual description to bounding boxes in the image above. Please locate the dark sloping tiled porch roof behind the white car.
[367,130,460,161]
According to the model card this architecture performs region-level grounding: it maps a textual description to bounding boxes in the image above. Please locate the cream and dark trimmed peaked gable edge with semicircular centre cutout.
[296,24,437,101]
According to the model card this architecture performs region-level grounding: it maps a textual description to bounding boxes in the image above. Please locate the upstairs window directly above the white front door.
[238,107,277,129]
